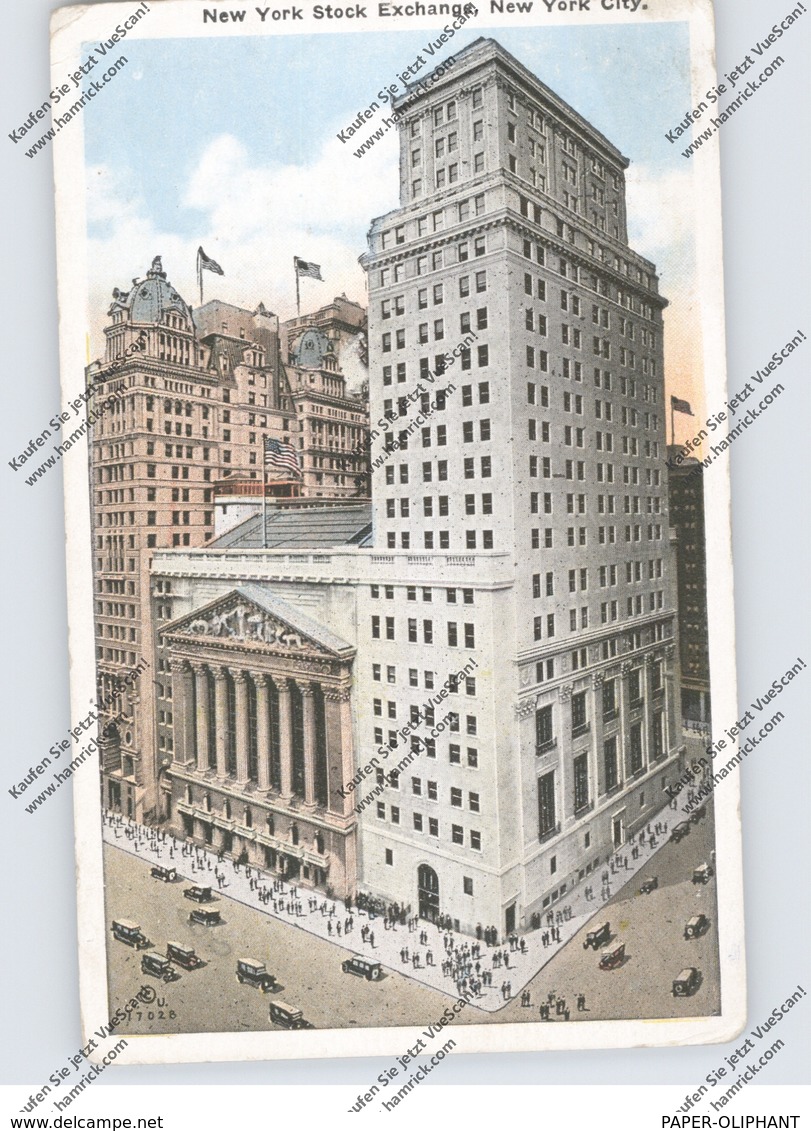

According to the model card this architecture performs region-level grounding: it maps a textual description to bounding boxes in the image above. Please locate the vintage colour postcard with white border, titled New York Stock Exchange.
[44,0,751,1067]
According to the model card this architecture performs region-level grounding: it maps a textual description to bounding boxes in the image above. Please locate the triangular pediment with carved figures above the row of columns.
[162,585,355,659]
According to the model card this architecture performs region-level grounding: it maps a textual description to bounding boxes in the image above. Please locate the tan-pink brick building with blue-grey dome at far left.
[87,257,364,819]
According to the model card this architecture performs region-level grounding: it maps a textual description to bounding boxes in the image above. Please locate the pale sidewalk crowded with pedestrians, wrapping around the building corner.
[103,805,682,1013]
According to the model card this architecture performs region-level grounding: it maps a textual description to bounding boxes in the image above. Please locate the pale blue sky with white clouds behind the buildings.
[83,23,700,432]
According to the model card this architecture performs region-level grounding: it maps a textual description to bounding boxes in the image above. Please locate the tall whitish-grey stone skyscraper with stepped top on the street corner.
[362,40,683,929]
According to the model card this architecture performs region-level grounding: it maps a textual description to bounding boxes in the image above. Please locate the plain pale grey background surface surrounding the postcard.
[0,0,811,1087]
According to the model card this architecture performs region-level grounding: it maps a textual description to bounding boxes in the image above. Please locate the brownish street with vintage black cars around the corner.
[104,805,721,1034]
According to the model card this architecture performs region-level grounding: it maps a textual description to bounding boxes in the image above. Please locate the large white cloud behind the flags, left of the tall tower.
[87,123,399,353]
